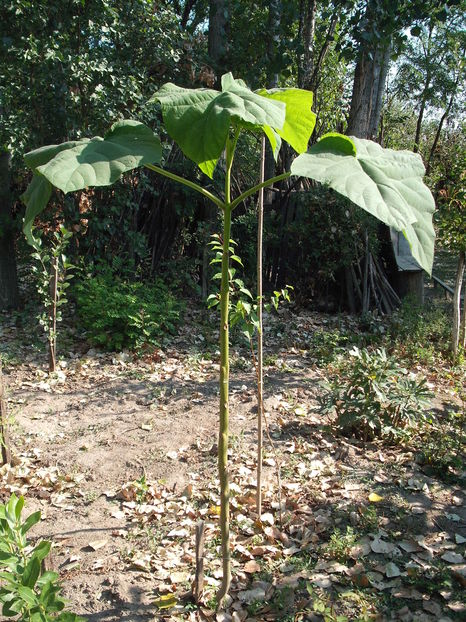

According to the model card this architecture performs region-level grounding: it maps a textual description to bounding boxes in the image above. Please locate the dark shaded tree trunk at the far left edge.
[0,151,19,310]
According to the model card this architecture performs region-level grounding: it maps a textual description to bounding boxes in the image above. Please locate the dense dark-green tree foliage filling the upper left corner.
[0,0,191,159]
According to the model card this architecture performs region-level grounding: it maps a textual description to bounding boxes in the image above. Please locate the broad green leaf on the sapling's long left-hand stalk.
[35,121,162,193]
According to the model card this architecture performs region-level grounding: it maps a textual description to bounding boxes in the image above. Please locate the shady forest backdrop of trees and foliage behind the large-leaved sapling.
[0,0,466,322]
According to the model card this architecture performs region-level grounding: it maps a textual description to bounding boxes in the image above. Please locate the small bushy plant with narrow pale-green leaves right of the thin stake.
[320,347,431,442]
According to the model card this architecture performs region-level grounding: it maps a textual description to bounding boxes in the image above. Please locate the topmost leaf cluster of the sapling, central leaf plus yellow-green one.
[150,73,315,177]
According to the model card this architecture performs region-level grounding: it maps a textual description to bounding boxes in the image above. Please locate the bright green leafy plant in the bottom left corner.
[0,494,84,622]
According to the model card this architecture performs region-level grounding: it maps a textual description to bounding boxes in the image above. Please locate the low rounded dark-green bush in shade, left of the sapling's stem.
[75,270,183,350]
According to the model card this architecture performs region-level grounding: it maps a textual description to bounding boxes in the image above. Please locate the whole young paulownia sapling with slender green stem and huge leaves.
[23,74,434,607]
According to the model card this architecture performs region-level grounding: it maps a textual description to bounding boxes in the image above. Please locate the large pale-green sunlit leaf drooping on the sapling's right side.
[291,134,435,274]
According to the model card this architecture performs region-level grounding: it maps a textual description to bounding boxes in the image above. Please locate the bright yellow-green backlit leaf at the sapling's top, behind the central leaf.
[256,89,316,158]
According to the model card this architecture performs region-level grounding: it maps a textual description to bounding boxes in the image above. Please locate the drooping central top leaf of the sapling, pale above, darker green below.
[150,73,286,178]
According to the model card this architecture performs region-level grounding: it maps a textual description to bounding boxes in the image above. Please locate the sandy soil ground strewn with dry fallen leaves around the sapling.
[0,312,466,622]
